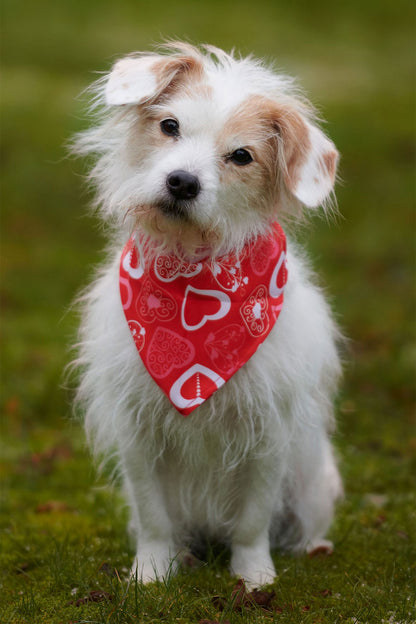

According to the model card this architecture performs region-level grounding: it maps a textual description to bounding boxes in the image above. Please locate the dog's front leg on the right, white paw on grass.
[230,459,279,588]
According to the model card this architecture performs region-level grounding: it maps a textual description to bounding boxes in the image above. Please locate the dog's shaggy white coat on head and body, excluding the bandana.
[73,45,342,586]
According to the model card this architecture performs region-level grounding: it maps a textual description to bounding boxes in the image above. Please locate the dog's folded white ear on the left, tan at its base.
[104,55,202,106]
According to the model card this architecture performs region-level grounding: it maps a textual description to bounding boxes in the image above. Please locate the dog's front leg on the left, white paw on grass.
[123,449,177,583]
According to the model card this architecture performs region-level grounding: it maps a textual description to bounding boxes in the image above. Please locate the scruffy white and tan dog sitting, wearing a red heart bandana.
[75,43,342,587]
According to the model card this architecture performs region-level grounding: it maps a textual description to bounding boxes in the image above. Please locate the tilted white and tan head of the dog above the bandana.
[77,44,338,252]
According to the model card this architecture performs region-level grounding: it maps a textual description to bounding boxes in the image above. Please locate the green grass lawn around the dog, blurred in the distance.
[0,0,416,624]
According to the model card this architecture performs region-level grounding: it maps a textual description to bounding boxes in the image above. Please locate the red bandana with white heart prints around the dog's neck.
[120,223,287,416]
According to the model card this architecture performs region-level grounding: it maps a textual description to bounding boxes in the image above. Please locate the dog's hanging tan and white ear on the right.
[278,112,338,208]
